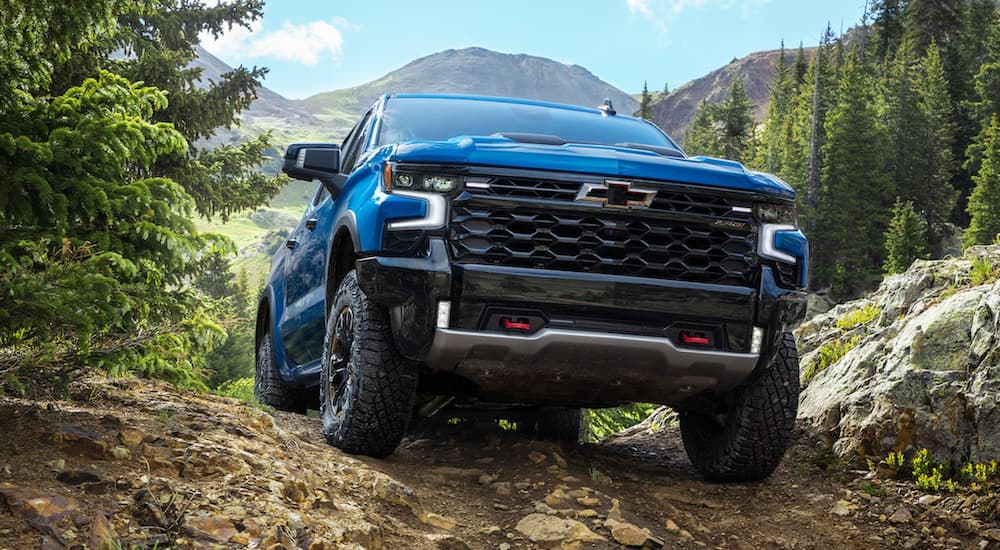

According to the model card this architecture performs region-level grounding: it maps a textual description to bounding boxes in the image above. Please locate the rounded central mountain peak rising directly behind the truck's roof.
[304,48,639,130]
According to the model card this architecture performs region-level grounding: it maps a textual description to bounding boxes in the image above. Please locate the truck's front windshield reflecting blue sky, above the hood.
[378,97,677,148]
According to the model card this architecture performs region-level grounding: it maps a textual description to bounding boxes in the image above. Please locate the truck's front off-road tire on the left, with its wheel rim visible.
[320,271,417,458]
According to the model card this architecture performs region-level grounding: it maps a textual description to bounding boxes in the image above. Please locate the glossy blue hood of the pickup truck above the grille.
[389,136,795,199]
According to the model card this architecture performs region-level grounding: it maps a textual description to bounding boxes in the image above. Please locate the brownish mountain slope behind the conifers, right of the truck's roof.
[653,48,815,143]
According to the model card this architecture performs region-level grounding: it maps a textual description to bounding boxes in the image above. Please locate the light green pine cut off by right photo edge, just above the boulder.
[962,115,1000,246]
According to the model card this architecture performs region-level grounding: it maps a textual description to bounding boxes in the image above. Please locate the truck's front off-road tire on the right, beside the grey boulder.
[678,332,799,481]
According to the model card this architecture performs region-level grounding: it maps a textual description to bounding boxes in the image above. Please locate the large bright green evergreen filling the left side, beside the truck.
[0,0,280,394]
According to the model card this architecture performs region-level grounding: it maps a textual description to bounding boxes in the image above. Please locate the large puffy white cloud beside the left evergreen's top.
[201,17,352,65]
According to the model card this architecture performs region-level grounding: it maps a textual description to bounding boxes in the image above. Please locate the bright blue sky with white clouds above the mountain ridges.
[205,0,864,98]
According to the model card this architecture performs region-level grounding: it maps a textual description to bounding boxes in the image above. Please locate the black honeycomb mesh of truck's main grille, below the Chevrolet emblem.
[449,205,757,286]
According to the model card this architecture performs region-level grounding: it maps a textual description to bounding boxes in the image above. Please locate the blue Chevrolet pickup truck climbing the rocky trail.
[256,94,808,481]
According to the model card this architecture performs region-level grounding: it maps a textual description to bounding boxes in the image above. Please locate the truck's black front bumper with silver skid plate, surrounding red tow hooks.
[357,238,805,406]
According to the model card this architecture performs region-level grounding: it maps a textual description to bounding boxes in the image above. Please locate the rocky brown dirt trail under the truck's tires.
[0,380,1000,550]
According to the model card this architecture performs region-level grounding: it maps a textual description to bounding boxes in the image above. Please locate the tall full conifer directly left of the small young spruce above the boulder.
[811,52,894,294]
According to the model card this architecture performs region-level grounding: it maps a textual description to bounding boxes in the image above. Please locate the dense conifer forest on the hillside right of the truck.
[684,0,1000,300]
